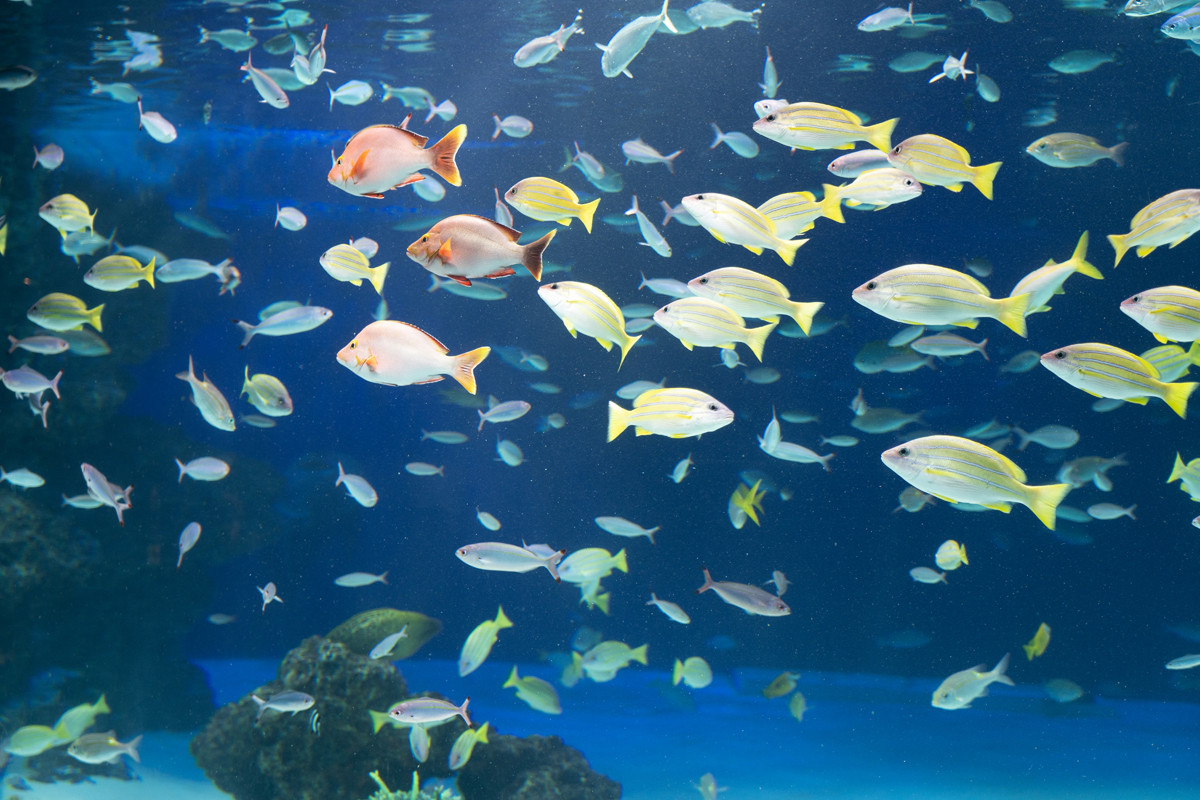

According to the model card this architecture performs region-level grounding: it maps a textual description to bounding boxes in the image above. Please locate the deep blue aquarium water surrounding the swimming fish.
[7,0,1200,796]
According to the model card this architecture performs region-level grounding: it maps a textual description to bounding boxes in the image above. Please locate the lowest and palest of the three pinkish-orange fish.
[337,319,492,395]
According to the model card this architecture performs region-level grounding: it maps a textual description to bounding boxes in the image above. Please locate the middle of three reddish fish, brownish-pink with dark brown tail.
[408,213,554,287]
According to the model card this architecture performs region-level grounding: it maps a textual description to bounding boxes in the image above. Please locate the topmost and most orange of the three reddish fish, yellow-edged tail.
[329,125,467,198]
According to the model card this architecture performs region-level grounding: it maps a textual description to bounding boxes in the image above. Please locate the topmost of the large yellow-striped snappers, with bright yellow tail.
[754,103,900,150]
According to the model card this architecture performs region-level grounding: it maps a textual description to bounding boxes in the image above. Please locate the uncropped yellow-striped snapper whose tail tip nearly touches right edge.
[1042,342,1200,417]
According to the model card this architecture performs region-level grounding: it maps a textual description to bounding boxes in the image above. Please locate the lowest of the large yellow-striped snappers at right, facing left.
[881,435,1070,530]
